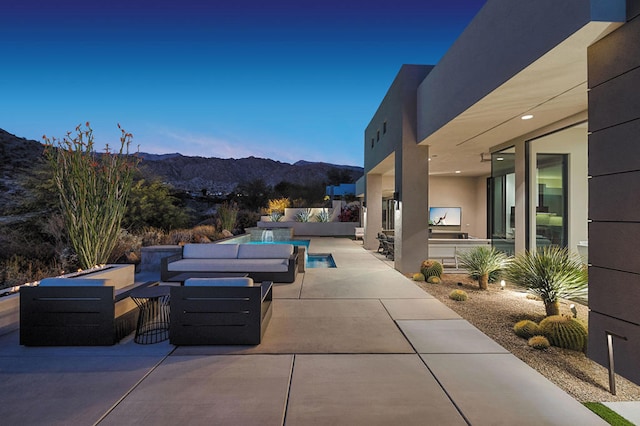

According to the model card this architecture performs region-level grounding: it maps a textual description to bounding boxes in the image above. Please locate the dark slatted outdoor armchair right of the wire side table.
[169,278,273,345]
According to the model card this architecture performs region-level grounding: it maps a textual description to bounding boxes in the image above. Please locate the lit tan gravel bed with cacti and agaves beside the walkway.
[416,274,640,402]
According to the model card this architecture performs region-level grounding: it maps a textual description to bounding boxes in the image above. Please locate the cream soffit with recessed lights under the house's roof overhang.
[420,22,622,176]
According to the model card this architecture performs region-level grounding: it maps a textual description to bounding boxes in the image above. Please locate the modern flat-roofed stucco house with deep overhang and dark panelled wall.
[358,0,640,383]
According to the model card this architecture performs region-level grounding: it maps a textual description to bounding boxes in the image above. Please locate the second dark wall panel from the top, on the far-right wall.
[589,68,640,132]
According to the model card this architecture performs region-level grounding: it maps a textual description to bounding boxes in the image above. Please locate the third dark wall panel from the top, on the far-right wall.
[589,119,640,176]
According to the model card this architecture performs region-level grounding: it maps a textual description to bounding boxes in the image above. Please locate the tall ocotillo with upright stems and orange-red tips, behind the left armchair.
[43,122,138,269]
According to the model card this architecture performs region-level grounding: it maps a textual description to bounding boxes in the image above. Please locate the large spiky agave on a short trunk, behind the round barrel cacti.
[505,246,588,316]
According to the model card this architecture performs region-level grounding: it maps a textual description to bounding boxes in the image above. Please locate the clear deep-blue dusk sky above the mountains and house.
[0,0,485,166]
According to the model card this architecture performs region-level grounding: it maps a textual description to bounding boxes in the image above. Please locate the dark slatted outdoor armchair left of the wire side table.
[20,278,157,346]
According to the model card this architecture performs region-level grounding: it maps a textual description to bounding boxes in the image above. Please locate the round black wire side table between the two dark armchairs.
[131,285,170,345]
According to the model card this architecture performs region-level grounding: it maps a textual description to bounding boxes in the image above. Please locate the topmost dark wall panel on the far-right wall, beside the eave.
[587,16,640,88]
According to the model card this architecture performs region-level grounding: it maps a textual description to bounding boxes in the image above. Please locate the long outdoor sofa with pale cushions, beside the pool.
[161,243,298,283]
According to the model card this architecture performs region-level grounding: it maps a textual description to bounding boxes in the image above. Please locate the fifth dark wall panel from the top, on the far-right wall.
[589,221,640,272]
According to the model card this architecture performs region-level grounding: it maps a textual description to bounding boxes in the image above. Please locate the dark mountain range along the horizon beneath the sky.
[0,129,364,214]
